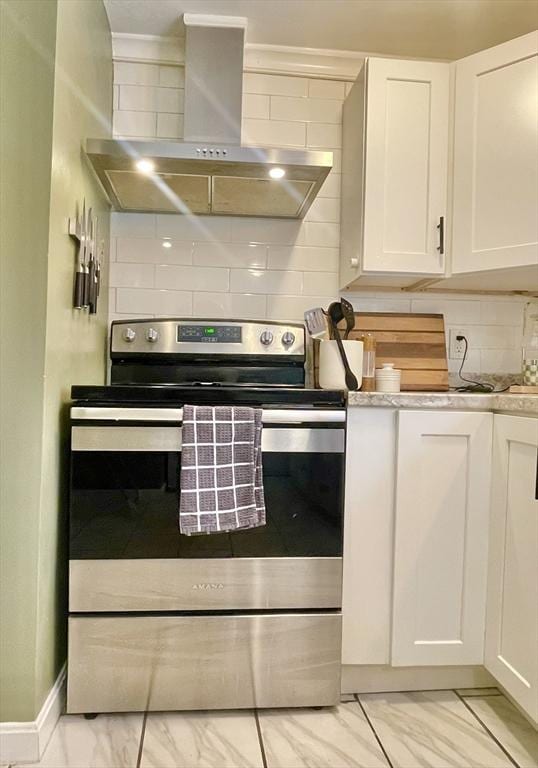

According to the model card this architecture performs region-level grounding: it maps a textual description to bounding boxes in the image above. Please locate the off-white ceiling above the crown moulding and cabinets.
[105,0,538,59]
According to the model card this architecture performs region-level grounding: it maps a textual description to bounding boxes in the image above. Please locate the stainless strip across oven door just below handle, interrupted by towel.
[71,424,345,453]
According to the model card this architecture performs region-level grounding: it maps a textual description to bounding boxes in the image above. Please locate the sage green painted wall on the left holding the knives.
[0,0,112,721]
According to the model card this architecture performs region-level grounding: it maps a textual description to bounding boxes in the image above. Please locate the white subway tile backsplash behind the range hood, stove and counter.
[109,62,526,373]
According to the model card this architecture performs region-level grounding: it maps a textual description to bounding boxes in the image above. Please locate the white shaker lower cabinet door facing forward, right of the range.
[391,411,493,666]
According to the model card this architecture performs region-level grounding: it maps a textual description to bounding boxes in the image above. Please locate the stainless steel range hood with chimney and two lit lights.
[86,14,332,219]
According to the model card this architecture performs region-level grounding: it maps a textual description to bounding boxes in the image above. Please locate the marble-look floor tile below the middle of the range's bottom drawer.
[140,712,263,768]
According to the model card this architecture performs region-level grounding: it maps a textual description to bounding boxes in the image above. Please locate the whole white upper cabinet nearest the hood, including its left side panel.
[341,59,449,287]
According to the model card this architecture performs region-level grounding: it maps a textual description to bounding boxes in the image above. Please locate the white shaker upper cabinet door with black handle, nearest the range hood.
[362,59,449,275]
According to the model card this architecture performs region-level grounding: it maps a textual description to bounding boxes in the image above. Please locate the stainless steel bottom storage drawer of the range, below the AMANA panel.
[67,613,341,713]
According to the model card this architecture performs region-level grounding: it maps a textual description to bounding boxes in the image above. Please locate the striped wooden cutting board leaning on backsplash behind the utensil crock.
[314,312,448,392]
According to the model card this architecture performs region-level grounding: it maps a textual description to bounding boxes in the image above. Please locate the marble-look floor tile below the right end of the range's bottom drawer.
[259,702,388,768]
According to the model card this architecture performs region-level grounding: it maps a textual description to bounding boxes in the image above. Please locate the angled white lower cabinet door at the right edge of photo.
[485,415,538,722]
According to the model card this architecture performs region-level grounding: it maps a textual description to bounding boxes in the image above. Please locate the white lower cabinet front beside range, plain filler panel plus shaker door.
[343,407,493,666]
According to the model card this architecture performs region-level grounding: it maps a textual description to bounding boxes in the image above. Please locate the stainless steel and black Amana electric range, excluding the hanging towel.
[67,319,346,714]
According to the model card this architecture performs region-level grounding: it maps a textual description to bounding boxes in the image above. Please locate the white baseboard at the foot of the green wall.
[0,664,66,764]
